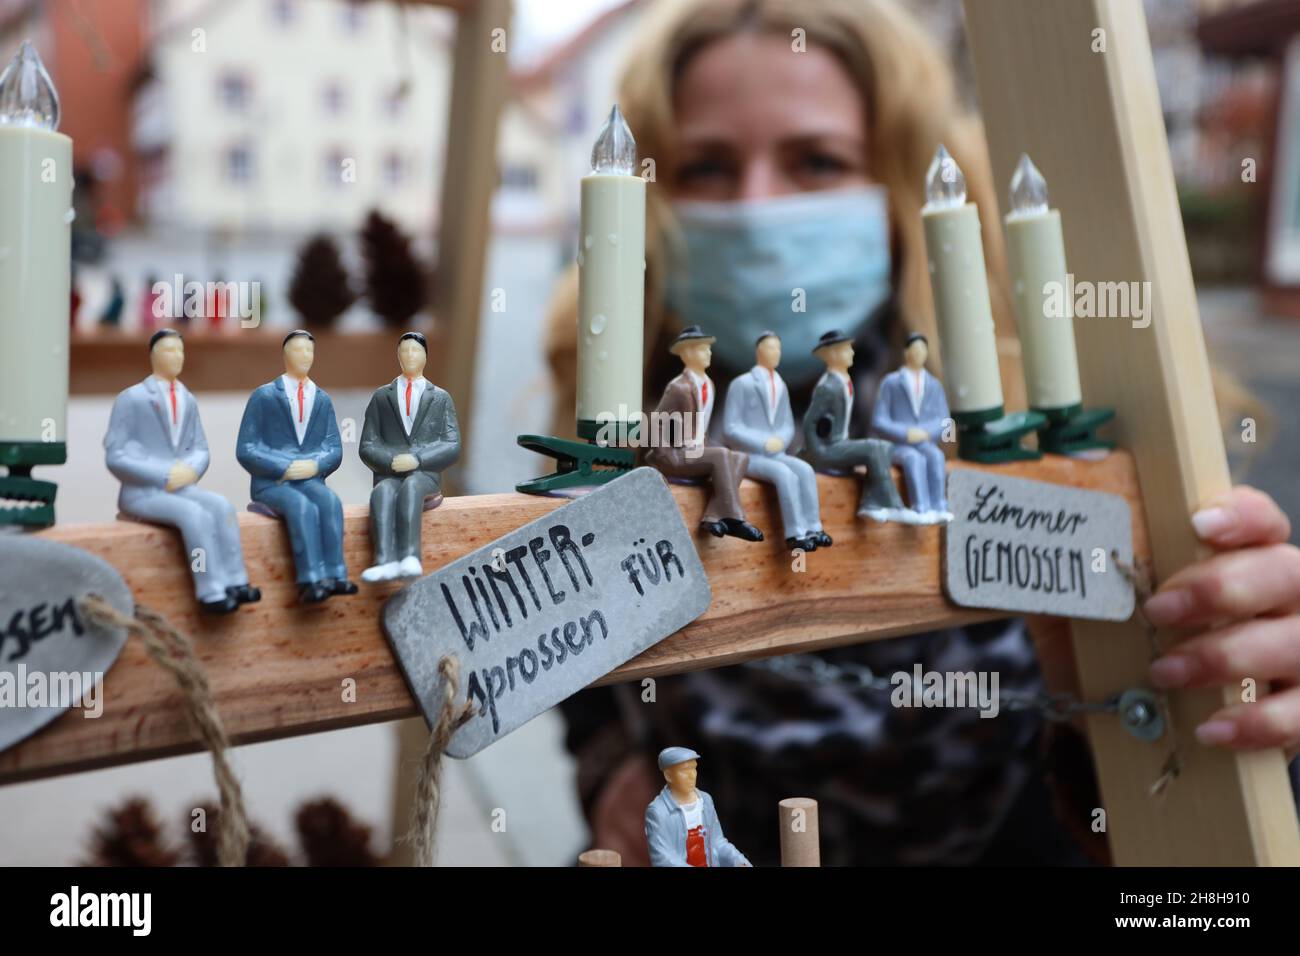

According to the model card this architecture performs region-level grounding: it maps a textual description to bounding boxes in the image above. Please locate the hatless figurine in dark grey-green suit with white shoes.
[361,332,460,581]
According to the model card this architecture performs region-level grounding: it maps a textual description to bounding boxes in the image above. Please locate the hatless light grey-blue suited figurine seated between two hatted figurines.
[723,332,832,551]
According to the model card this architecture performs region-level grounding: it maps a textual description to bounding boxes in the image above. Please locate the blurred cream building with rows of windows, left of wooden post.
[131,0,451,235]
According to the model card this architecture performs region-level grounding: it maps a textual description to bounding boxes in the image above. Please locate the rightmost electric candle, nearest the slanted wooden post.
[1006,156,1083,410]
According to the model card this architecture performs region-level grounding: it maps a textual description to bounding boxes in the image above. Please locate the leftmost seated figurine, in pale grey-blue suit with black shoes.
[104,329,261,614]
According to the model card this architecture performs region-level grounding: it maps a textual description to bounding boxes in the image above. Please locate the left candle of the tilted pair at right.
[920,146,1002,414]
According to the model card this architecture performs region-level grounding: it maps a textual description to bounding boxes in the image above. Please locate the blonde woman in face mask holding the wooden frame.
[549,0,1300,865]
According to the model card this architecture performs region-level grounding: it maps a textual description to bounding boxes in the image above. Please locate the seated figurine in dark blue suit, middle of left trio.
[235,329,356,602]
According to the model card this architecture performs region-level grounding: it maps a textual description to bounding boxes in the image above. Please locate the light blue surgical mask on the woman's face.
[666,186,891,384]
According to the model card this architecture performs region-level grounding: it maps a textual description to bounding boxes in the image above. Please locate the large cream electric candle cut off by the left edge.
[0,43,73,445]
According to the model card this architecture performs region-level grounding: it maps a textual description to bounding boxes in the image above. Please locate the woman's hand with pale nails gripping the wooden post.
[1143,486,1300,754]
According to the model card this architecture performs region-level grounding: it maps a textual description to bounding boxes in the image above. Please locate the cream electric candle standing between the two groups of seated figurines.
[577,105,646,438]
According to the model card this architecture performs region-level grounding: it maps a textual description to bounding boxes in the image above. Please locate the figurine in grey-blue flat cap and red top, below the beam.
[646,747,751,866]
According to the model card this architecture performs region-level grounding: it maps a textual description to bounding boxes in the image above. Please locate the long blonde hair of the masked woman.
[547,0,1023,429]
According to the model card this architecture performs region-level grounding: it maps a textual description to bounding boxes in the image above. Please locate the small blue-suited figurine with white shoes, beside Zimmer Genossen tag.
[871,332,953,524]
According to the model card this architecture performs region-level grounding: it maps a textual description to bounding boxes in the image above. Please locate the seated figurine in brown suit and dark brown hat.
[645,325,763,541]
